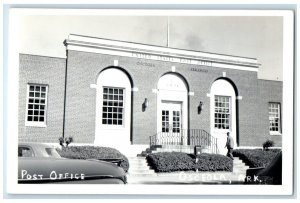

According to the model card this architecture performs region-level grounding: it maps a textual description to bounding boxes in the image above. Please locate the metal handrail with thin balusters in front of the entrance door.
[149,129,219,153]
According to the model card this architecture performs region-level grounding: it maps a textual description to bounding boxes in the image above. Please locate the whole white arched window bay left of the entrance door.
[95,68,131,146]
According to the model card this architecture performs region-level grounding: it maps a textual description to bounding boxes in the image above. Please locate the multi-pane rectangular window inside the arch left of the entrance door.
[102,87,124,125]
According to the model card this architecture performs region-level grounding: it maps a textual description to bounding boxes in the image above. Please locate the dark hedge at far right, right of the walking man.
[233,149,281,168]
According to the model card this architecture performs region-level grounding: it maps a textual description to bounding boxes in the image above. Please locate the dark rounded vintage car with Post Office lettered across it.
[18,143,127,184]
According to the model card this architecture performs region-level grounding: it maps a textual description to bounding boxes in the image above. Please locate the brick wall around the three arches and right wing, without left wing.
[65,51,282,146]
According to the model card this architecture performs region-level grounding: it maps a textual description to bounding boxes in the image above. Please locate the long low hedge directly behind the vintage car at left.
[57,146,129,172]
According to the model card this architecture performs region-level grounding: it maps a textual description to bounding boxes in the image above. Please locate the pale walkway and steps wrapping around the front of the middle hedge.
[128,157,249,184]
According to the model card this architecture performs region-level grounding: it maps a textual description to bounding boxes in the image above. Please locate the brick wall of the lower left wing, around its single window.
[18,54,66,142]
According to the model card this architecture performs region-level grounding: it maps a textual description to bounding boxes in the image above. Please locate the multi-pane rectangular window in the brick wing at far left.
[26,84,48,126]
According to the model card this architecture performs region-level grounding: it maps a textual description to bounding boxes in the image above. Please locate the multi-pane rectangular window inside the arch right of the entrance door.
[214,96,231,129]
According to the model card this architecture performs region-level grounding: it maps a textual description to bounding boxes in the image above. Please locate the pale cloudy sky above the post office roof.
[18,15,283,81]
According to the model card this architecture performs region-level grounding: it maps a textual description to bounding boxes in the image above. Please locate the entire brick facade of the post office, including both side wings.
[19,40,282,146]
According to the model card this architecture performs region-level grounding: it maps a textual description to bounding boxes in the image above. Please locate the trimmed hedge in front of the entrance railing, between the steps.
[146,152,233,172]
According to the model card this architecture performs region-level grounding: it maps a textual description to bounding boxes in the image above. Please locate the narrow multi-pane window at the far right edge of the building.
[269,102,281,133]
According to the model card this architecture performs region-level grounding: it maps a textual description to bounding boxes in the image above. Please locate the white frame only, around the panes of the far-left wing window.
[25,83,49,127]
